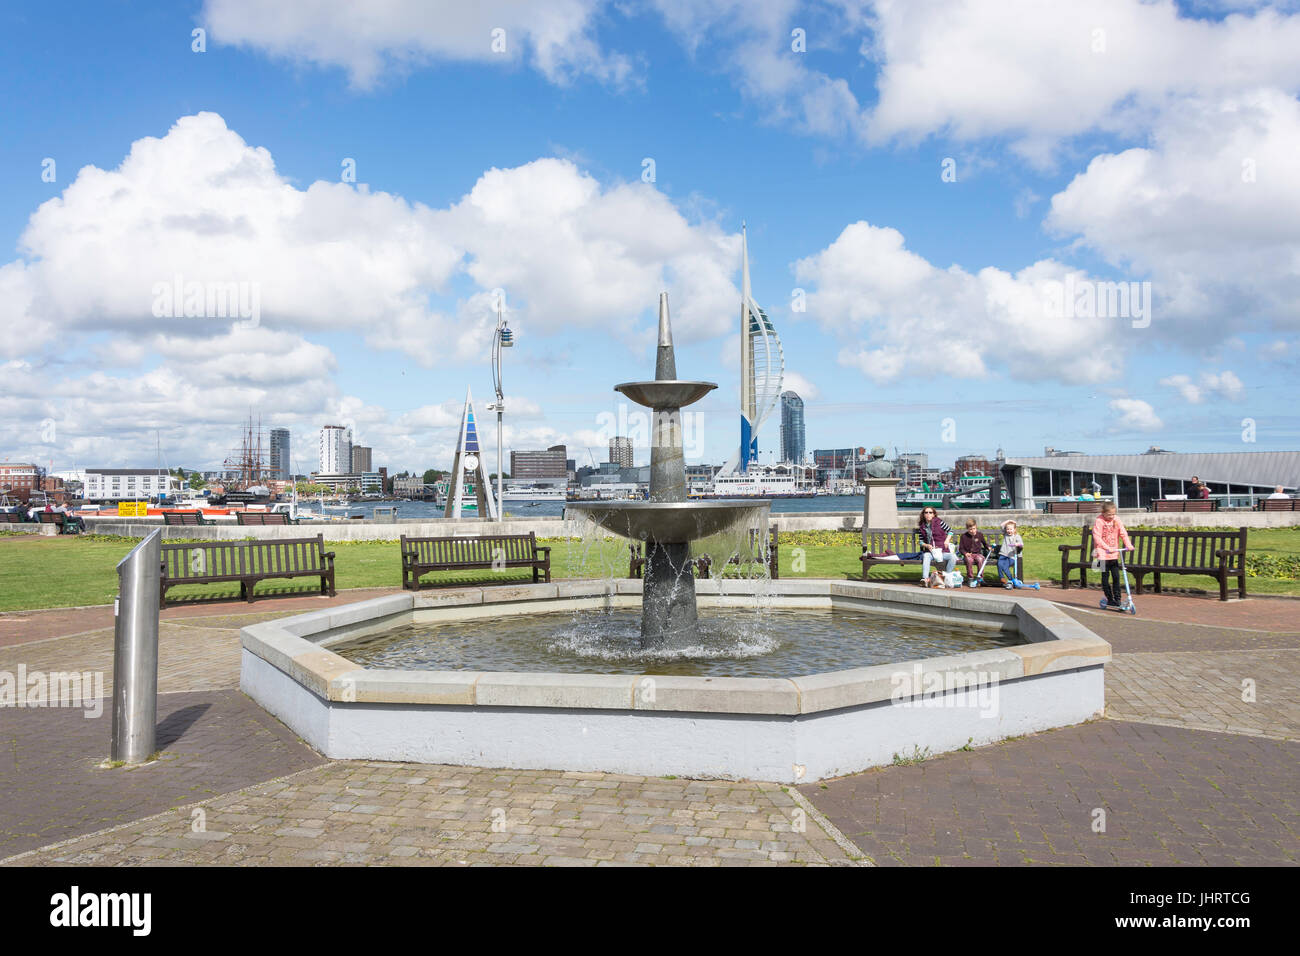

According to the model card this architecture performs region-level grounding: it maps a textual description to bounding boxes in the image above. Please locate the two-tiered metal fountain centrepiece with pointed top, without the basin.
[568,293,768,648]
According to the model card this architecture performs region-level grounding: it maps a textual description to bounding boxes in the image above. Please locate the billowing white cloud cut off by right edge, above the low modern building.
[1045,90,1300,338]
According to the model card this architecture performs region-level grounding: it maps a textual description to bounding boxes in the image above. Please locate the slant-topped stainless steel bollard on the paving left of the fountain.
[111,529,163,763]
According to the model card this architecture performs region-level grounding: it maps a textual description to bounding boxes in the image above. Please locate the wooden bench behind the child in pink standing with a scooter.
[1060,527,1245,601]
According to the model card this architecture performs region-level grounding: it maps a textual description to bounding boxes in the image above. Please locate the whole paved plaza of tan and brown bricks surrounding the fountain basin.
[0,589,1300,866]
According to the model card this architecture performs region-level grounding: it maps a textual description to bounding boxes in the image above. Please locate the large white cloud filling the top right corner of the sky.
[867,0,1300,163]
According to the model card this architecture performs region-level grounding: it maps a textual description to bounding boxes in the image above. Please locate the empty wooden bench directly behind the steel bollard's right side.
[159,535,335,607]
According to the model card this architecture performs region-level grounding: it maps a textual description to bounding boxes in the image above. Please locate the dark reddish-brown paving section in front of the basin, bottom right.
[800,721,1300,866]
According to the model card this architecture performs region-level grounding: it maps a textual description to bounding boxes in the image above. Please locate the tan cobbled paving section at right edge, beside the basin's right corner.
[1106,649,1300,740]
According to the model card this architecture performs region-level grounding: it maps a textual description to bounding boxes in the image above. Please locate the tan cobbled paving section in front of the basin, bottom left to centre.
[12,761,849,866]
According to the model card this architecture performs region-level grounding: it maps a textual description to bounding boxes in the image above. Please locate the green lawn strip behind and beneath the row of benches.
[0,528,1300,611]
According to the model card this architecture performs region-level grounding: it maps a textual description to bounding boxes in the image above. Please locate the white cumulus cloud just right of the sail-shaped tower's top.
[794,221,1126,386]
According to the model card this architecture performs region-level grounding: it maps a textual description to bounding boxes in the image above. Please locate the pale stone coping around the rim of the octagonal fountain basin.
[241,579,1110,715]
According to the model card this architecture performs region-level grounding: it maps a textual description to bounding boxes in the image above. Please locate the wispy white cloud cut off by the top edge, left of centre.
[200,0,633,88]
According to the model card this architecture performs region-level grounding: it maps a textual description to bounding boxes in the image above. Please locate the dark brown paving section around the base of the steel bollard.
[0,691,322,858]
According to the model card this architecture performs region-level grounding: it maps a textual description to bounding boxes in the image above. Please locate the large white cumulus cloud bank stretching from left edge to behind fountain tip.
[0,113,740,468]
